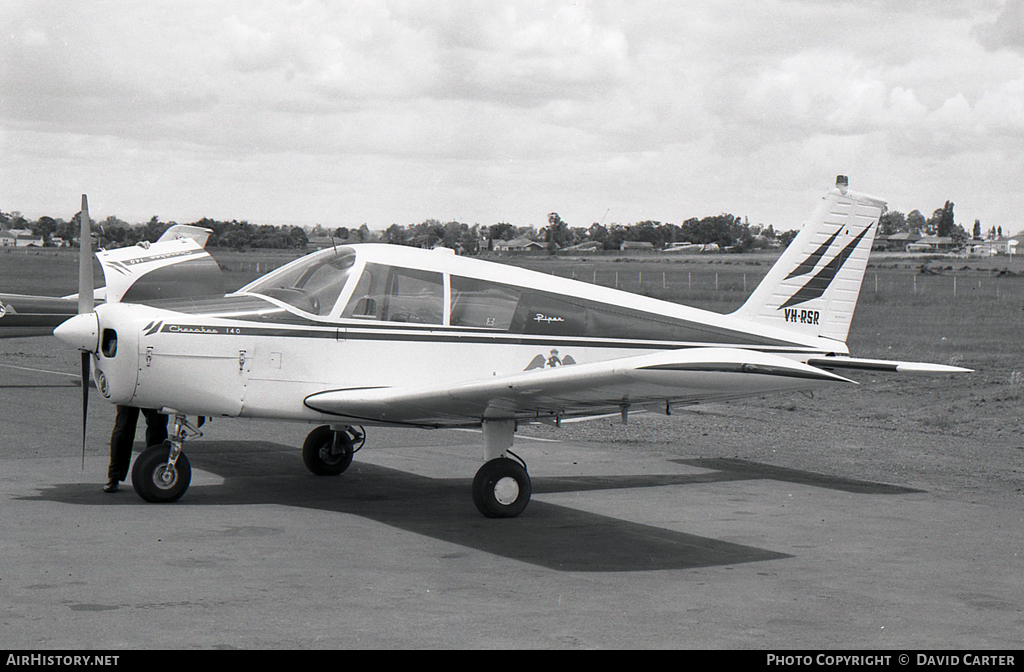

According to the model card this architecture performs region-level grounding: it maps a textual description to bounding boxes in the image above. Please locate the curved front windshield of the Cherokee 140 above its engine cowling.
[244,247,355,316]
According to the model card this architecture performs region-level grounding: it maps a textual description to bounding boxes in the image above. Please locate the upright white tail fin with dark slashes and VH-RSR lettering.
[733,175,886,342]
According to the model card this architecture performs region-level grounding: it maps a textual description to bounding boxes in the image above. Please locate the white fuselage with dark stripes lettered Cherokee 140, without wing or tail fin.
[79,245,847,424]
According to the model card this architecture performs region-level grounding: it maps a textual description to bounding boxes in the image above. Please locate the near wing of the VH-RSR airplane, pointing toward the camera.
[305,347,853,426]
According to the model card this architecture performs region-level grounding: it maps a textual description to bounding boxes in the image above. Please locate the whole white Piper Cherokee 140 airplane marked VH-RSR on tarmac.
[54,176,969,517]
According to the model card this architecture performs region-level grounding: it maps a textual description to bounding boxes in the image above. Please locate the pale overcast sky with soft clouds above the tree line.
[0,0,1024,233]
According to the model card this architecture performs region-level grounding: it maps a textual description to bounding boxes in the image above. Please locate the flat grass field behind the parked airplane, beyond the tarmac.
[0,242,1024,500]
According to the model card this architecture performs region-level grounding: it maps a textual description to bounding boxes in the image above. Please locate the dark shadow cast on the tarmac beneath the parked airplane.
[20,442,916,572]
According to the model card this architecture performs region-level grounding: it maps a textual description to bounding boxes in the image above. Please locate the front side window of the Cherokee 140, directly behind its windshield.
[341,263,444,325]
